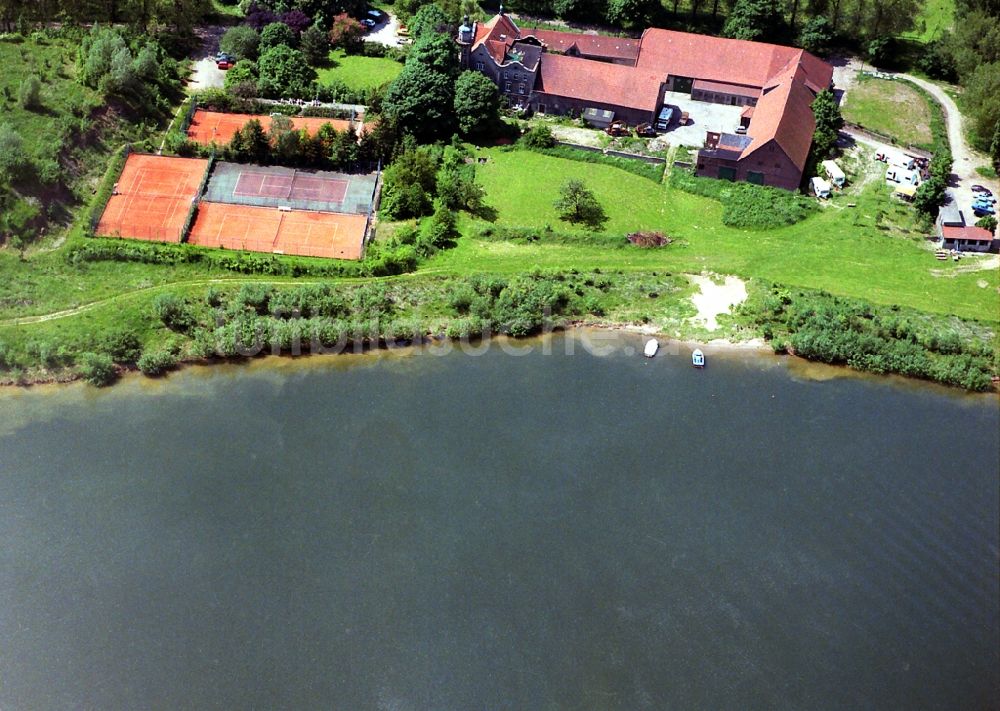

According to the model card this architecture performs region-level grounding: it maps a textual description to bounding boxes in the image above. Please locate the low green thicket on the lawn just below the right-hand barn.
[670,170,815,229]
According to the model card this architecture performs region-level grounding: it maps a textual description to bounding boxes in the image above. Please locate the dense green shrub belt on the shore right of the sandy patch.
[738,286,995,390]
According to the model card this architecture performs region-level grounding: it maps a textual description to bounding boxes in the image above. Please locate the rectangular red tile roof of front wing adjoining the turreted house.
[535,54,663,113]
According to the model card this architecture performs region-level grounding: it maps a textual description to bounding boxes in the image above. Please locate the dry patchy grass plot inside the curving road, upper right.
[843,78,932,145]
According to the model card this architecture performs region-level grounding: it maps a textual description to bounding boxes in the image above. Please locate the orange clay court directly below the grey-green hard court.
[188,202,368,259]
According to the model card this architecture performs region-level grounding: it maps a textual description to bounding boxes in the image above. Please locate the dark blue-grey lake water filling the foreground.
[0,338,1000,711]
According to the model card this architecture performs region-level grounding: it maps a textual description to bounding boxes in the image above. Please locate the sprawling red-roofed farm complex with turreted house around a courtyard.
[458,12,833,190]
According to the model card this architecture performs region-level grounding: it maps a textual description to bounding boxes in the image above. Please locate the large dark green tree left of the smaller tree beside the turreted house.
[382,62,455,141]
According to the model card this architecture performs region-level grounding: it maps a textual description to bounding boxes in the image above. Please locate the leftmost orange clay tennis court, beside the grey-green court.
[95,153,208,242]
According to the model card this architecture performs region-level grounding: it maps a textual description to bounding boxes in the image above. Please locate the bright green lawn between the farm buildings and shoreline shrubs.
[426,149,1000,323]
